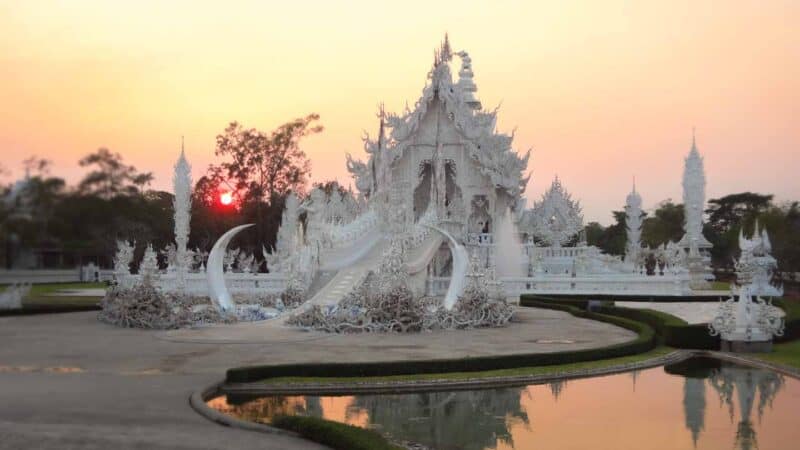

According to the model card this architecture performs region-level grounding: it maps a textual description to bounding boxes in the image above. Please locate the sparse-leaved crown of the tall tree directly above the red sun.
[208,114,323,203]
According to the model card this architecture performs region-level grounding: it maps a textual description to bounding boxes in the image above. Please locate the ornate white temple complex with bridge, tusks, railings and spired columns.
[116,38,724,320]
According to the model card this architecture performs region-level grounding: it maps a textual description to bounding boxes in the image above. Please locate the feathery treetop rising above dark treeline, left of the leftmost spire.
[78,147,153,199]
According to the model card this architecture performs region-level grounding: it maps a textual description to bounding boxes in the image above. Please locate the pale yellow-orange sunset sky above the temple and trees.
[0,0,800,223]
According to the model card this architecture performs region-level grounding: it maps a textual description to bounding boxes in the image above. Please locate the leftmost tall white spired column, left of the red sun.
[172,136,192,292]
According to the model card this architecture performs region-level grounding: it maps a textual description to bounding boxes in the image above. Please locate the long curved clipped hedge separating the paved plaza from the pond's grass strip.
[226,305,658,383]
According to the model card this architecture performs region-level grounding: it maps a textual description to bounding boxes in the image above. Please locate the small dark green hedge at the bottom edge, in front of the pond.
[272,416,401,450]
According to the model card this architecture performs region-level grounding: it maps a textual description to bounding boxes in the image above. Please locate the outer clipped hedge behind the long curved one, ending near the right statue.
[520,296,720,350]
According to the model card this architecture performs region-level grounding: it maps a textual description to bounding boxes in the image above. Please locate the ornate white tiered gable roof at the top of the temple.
[348,36,530,197]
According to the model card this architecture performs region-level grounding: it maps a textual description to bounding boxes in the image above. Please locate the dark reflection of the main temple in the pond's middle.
[350,388,528,450]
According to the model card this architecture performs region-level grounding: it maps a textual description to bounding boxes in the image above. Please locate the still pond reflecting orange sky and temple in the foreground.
[208,358,800,450]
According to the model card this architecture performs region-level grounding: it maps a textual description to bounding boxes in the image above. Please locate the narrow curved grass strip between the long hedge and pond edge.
[258,346,675,384]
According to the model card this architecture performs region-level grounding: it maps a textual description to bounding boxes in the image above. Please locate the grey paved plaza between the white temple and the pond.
[0,308,635,450]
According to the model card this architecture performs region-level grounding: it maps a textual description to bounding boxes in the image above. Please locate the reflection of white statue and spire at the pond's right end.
[664,359,784,450]
